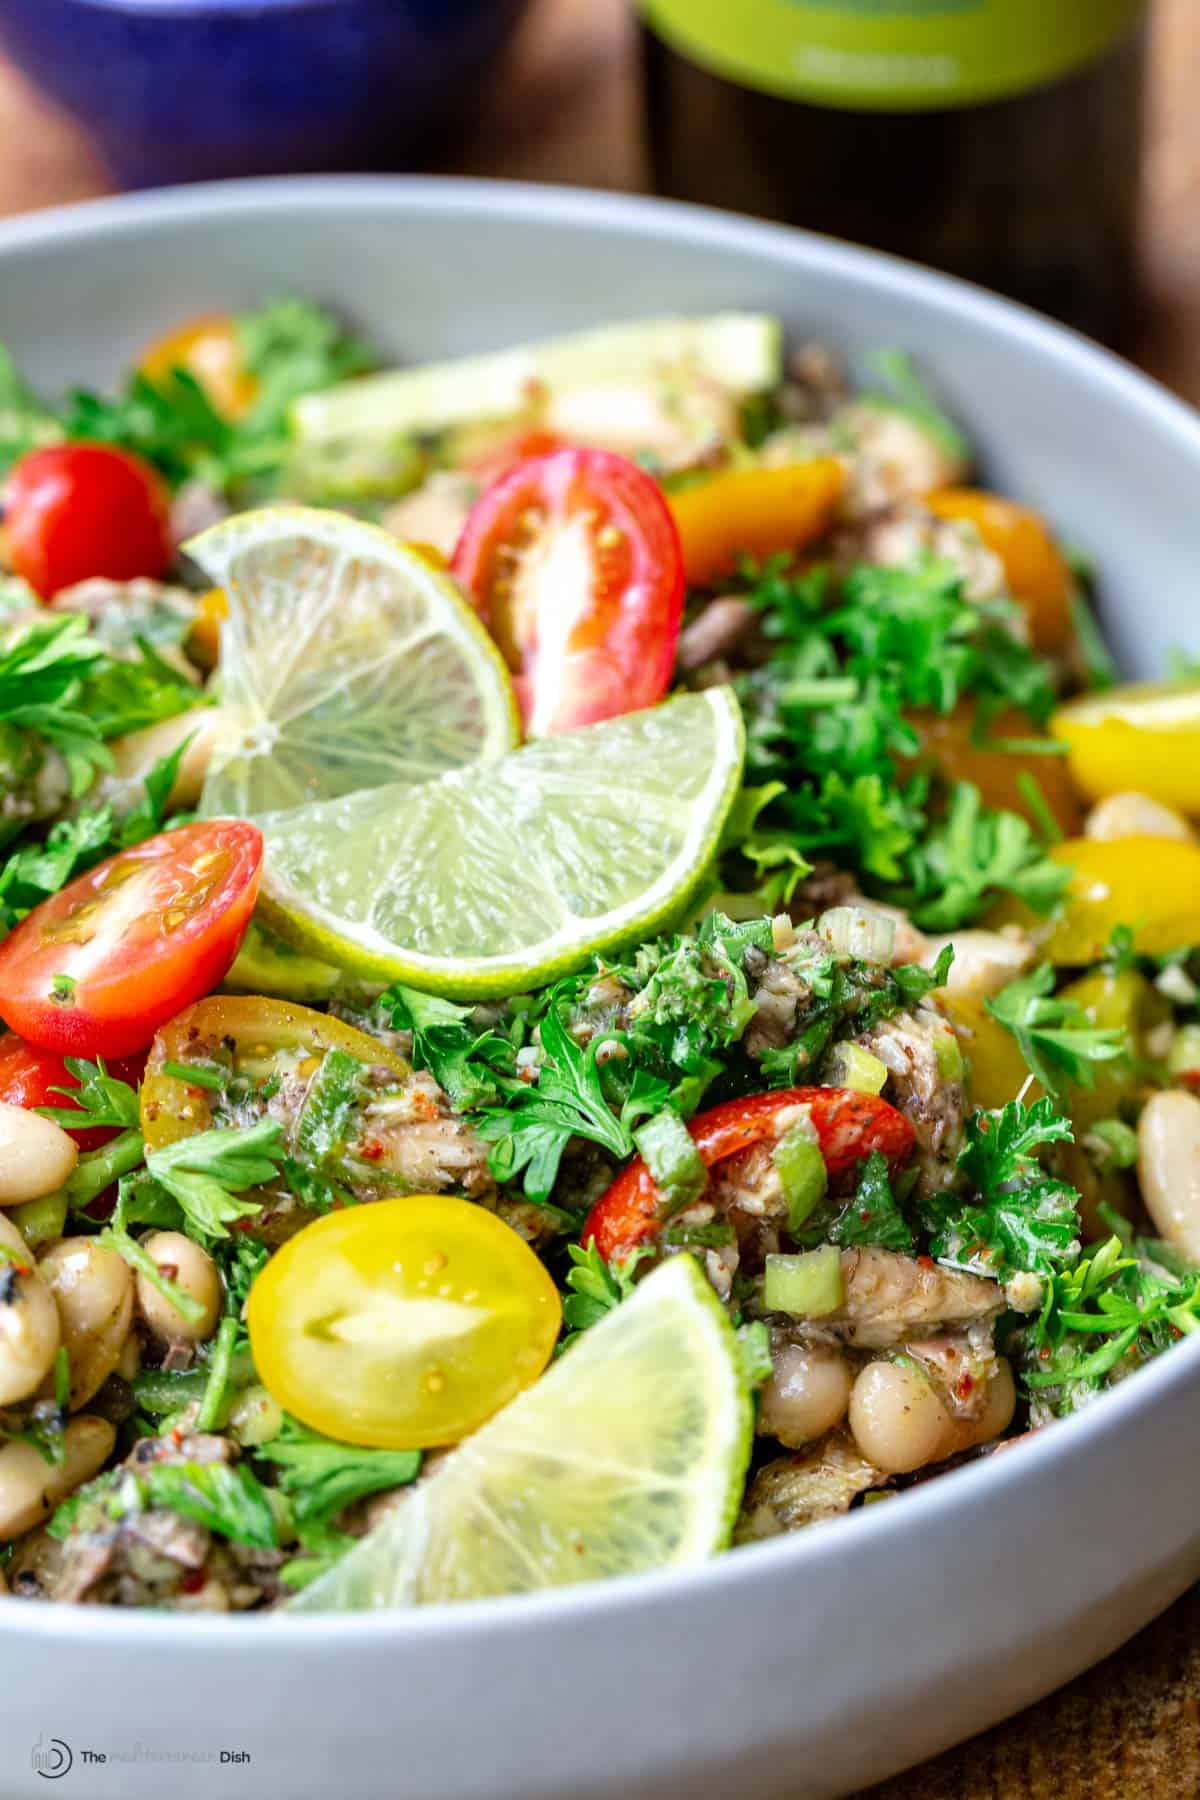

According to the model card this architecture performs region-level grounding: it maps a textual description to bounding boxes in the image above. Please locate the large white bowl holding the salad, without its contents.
[0,180,1200,1800]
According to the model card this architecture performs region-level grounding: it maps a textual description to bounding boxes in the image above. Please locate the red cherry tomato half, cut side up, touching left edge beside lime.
[0,819,263,1057]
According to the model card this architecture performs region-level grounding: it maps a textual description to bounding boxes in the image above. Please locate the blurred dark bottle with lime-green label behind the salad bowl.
[639,0,1146,340]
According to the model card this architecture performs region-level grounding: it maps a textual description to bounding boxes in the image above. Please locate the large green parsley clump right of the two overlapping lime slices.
[738,560,1069,931]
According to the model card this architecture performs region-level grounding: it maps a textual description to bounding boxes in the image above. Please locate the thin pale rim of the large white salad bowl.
[0,175,1200,1656]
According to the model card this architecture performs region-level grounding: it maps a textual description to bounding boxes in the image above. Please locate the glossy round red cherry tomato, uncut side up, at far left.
[4,445,171,599]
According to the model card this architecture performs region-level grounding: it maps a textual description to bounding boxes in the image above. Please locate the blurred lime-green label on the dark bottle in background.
[640,0,1146,112]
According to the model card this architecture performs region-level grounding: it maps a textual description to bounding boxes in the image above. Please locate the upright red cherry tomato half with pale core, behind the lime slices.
[452,450,684,738]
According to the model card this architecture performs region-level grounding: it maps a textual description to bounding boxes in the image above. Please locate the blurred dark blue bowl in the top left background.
[0,0,525,187]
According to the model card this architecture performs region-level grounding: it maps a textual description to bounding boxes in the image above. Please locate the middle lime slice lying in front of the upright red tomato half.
[259,688,743,997]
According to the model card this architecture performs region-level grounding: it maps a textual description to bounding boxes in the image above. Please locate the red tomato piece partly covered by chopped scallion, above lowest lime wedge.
[581,1087,916,1262]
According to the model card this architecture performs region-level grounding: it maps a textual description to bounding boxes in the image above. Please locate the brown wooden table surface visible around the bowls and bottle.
[0,0,1200,1800]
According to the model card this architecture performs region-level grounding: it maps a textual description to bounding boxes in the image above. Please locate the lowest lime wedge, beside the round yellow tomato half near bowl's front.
[291,1256,752,1611]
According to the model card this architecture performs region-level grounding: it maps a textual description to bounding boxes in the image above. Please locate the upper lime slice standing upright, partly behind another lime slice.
[185,506,518,819]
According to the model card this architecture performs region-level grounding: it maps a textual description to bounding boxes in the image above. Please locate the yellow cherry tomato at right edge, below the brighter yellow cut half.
[990,837,1200,967]
